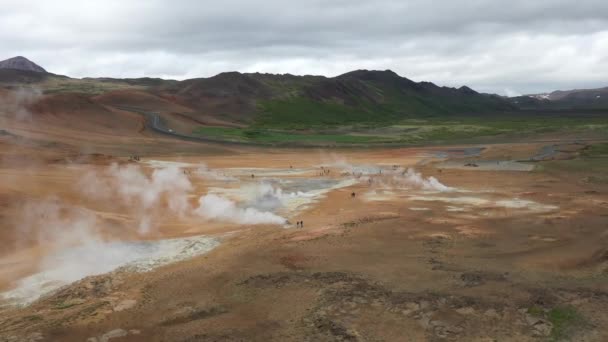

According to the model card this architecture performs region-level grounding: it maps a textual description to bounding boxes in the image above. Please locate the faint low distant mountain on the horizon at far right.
[509,87,608,109]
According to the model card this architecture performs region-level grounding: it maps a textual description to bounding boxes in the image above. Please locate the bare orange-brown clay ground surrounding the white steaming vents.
[0,98,608,342]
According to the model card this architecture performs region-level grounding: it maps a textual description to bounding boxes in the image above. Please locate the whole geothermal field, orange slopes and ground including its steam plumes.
[0,66,608,342]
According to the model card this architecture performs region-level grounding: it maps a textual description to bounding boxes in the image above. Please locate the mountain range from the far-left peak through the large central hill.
[0,57,516,127]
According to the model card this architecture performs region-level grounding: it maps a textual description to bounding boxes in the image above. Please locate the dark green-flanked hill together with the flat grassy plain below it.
[179,70,608,145]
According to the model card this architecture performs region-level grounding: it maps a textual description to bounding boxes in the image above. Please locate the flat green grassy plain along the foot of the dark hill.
[194,115,608,146]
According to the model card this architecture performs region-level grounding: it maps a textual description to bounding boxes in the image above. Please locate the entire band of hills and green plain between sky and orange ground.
[0,59,608,146]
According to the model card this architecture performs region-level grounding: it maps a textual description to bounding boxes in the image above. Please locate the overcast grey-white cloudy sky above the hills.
[0,0,608,95]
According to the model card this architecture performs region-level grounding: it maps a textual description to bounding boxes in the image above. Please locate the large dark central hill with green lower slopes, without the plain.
[159,70,515,126]
